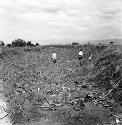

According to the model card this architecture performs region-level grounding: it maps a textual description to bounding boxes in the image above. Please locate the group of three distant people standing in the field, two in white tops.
[52,49,92,65]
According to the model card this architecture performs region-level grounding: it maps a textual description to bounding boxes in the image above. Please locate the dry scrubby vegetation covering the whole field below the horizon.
[0,45,122,125]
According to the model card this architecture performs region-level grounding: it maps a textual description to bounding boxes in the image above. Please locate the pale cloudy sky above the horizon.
[0,0,122,44]
